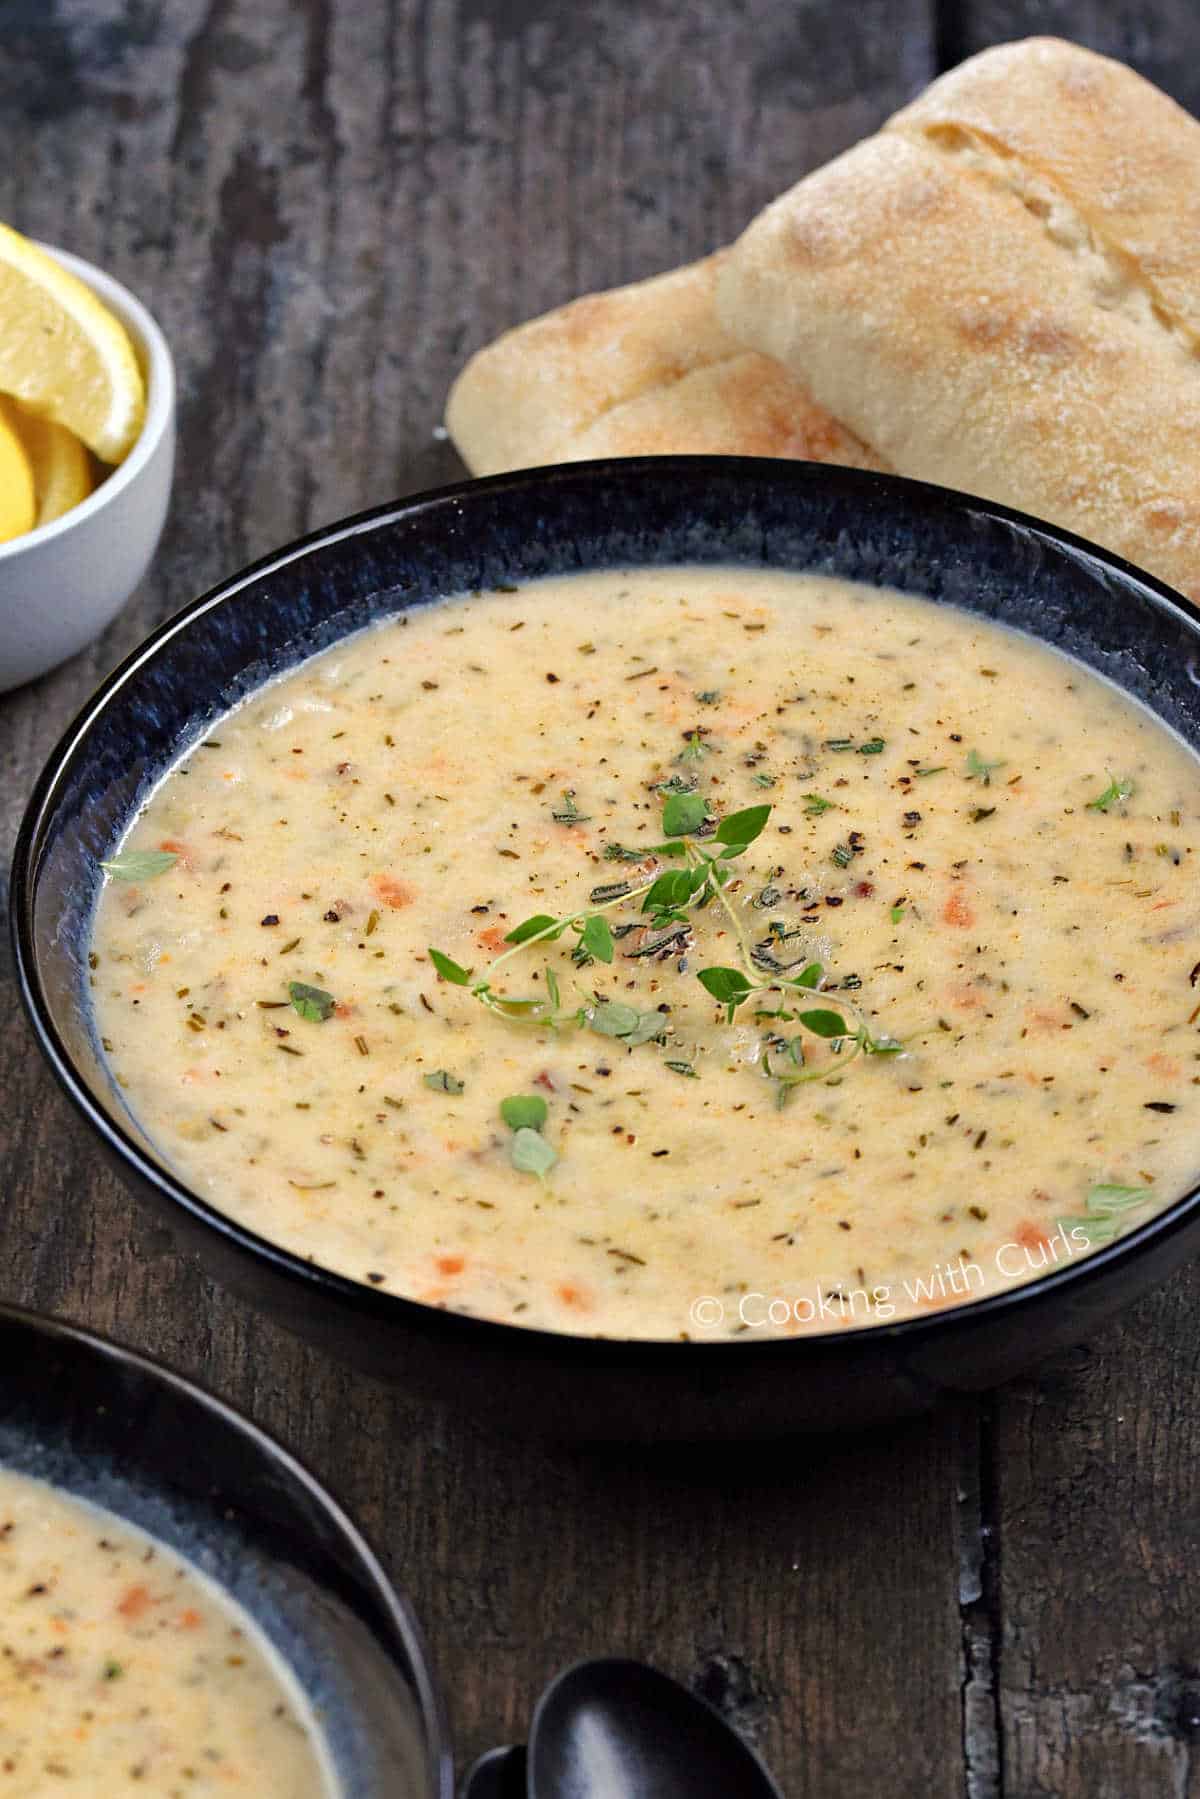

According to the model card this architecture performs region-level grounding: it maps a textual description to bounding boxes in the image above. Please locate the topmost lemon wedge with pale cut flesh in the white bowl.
[0,225,146,462]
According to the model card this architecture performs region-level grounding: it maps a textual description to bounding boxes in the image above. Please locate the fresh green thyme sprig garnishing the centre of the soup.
[428,792,903,1085]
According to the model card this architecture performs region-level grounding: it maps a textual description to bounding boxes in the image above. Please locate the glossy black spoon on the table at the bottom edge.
[461,1657,783,1799]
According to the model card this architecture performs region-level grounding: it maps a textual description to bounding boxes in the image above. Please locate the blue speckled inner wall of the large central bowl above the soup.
[13,457,1200,1338]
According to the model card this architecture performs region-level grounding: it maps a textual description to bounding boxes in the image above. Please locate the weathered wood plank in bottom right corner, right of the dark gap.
[993,1270,1200,1799]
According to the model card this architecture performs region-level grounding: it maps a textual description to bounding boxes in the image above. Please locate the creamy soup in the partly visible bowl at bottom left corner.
[0,1470,335,1799]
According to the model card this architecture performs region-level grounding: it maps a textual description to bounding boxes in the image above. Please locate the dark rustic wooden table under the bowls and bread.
[0,0,1200,1799]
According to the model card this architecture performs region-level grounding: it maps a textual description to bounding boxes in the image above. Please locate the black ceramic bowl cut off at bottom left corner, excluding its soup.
[0,1306,453,1799]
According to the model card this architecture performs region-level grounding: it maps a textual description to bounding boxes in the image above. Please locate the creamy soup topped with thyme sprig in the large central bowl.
[92,568,1200,1338]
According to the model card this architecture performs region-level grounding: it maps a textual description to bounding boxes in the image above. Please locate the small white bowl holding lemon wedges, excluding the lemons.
[0,245,175,693]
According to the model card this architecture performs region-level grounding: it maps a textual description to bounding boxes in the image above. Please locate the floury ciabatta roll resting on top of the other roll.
[718,40,1200,594]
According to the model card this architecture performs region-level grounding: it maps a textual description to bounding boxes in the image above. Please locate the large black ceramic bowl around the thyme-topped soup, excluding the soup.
[13,457,1200,1439]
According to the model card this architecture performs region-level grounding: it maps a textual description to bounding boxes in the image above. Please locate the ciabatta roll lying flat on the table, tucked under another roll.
[446,254,880,475]
